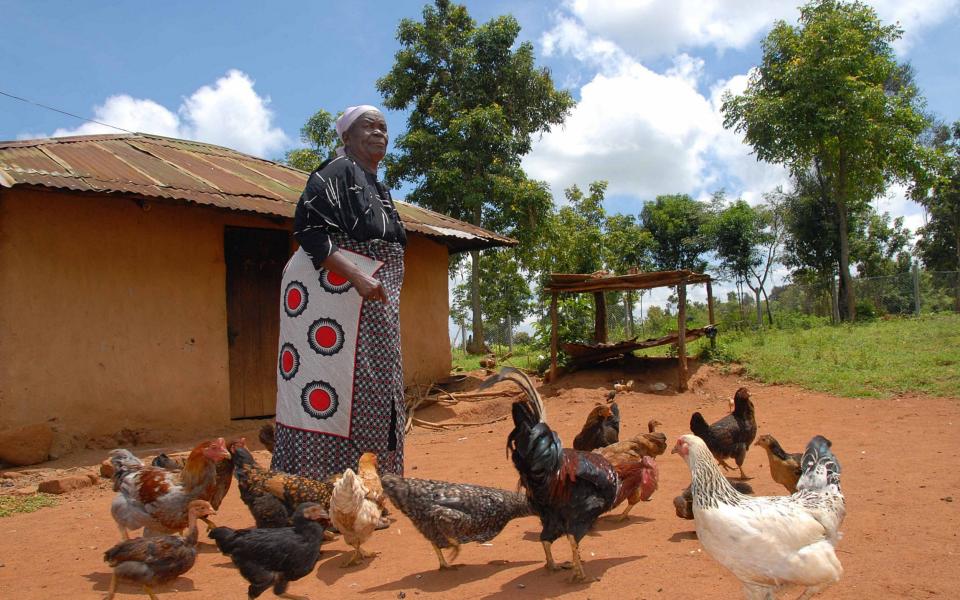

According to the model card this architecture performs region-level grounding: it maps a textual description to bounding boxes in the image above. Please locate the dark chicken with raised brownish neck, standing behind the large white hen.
[690,388,757,479]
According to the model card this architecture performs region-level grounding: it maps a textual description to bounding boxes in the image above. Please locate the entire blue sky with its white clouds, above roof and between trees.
[0,0,960,318]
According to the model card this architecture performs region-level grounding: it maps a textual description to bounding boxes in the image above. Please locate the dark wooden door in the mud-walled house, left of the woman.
[223,227,290,419]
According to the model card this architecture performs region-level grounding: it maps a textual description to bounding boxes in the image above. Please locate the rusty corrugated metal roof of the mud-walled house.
[0,133,517,252]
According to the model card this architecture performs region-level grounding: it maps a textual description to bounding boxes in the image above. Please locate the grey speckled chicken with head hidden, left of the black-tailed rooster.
[381,475,534,569]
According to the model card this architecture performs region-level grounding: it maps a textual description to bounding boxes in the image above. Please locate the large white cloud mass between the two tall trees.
[524,22,786,207]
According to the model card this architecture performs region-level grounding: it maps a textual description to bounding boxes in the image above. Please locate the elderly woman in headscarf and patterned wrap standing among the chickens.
[272,105,406,479]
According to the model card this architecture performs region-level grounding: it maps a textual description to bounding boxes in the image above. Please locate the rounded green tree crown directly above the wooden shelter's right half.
[640,194,710,273]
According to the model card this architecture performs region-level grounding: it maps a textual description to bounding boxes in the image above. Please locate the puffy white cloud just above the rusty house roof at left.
[37,70,289,156]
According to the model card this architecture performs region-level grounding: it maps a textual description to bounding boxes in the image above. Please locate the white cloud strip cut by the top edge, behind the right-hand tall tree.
[550,0,958,58]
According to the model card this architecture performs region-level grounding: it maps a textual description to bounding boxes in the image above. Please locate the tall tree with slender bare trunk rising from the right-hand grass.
[722,0,926,320]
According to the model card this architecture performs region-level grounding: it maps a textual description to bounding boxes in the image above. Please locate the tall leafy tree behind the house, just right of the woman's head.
[377,0,574,351]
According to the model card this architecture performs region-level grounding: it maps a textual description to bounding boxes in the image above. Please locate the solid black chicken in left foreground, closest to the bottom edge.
[209,502,330,598]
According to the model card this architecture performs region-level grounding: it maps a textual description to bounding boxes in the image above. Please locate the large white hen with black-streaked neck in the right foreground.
[673,435,845,600]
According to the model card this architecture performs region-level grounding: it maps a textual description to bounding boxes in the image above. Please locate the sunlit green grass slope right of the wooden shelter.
[716,313,960,398]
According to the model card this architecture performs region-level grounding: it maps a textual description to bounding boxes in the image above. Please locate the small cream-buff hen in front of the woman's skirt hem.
[330,469,381,567]
